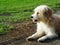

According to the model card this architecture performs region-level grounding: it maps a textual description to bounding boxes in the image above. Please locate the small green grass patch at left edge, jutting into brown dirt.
[0,23,14,34]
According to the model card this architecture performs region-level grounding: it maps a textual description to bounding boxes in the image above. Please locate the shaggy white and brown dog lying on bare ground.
[27,5,60,41]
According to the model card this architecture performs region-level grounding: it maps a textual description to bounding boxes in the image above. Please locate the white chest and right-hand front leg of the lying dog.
[37,22,58,41]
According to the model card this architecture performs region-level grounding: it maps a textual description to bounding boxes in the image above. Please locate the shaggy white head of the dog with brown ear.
[31,5,52,22]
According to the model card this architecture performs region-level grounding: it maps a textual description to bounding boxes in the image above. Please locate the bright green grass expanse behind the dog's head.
[0,0,60,33]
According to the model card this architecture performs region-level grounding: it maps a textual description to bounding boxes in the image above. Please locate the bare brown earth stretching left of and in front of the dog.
[0,12,60,45]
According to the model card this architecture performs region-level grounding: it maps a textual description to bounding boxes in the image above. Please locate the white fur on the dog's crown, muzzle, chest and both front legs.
[27,5,58,41]
